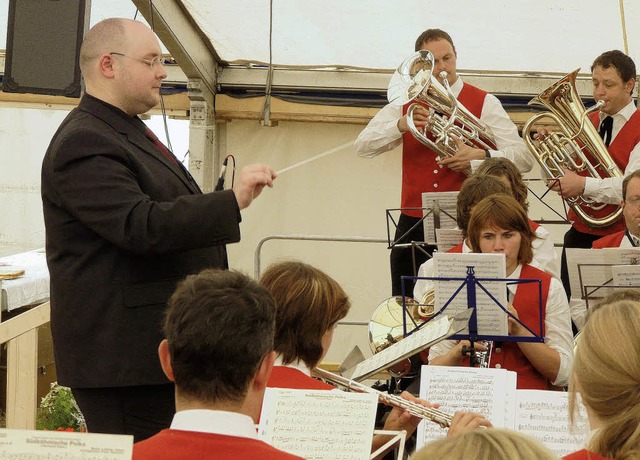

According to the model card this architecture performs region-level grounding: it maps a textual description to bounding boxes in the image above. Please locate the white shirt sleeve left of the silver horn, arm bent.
[355,104,402,158]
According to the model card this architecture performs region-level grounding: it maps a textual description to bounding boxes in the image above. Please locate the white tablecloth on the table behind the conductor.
[0,249,49,311]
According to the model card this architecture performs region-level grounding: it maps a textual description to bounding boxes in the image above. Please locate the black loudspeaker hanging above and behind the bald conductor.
[2,0,89,97]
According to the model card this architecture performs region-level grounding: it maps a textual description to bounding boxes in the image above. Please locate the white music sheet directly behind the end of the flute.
[416,366,509,450]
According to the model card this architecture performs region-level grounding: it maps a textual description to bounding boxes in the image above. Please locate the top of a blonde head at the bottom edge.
[411,428,559,460]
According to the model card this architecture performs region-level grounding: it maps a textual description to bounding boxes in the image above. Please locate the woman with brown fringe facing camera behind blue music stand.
[429,194,573,389]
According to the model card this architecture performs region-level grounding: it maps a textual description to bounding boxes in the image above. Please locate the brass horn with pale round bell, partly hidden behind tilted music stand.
[369,290,435,378]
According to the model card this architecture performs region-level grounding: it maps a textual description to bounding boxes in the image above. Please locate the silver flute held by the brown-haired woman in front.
[312,367,453,428]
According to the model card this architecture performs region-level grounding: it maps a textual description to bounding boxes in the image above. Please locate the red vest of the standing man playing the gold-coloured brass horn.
[568,110,640,236]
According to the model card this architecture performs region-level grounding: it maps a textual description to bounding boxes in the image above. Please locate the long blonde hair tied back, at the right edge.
[569,300,640,460]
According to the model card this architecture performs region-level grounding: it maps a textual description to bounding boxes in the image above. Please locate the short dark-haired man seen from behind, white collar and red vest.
[133,269,299,460]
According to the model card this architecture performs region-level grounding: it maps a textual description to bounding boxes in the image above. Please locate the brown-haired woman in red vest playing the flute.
[260,261,491,450]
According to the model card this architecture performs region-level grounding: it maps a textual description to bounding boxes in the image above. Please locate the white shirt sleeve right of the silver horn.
[480,94,534,174]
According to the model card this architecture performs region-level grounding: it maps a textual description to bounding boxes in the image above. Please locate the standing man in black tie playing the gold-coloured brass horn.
[551,50,640,297]
